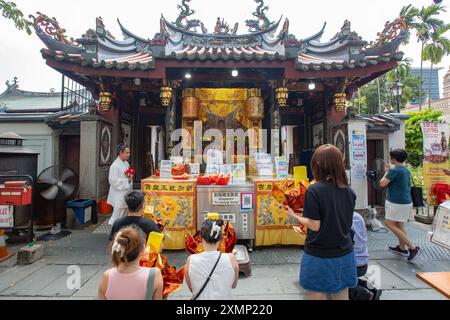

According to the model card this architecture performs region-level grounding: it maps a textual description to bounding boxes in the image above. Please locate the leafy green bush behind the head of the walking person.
[405,109,443,166]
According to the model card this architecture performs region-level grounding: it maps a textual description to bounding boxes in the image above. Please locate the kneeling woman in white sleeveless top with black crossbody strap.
[185,220,239,300]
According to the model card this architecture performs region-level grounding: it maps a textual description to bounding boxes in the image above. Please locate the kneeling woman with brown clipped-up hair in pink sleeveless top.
[98,226,164,300]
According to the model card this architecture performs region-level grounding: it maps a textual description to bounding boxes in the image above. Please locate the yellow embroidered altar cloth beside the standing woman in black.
[255,181,305,246]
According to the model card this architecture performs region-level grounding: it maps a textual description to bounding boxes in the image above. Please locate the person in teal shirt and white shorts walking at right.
[380,149,422,262]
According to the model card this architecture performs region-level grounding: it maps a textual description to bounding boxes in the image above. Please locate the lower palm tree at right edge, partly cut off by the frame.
[422,24,450,108]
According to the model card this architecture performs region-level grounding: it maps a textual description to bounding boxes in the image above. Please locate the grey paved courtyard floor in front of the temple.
[0,217,450,300]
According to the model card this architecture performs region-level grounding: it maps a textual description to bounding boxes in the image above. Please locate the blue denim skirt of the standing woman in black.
[300,251,358,293]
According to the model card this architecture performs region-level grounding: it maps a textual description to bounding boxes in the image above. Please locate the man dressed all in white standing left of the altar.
[107,144,132,225]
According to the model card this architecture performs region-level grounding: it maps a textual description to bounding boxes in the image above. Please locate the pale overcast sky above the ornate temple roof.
[0,0,450,94]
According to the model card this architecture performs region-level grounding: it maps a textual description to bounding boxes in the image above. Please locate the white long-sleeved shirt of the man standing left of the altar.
[107,157,131,208]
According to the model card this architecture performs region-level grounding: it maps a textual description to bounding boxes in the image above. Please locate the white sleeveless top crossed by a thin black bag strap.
[189,251,235,300]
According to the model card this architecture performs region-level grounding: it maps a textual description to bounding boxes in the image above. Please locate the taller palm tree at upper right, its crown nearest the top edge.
[400,3,446,110]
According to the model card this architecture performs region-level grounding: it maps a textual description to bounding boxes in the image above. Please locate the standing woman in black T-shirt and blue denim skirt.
[287,145,358,300]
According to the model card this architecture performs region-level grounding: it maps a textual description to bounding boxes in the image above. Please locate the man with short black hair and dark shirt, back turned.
[109,190,161,240]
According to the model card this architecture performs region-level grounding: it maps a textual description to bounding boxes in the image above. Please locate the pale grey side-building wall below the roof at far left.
[0,122,53,174]
